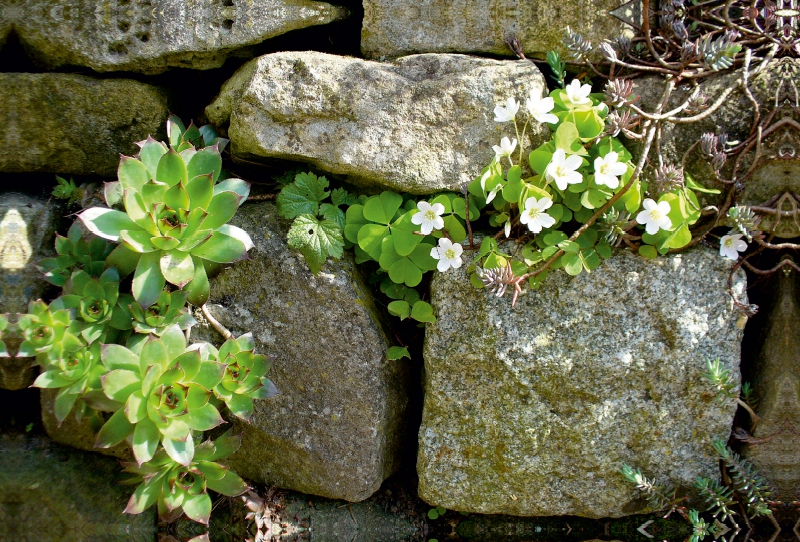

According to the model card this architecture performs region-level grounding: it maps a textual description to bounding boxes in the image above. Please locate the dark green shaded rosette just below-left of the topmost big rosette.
[37,223,113,287]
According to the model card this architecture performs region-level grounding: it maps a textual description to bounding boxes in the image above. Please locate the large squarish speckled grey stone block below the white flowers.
[417,249,745,518]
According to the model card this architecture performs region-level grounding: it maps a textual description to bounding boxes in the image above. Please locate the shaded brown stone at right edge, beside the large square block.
[743,260,800,502]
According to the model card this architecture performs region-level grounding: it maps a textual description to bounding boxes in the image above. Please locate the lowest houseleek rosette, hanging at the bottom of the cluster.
[125,433,248,524]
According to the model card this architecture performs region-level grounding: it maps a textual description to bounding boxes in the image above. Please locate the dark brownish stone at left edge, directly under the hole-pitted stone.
[0,73,169,176]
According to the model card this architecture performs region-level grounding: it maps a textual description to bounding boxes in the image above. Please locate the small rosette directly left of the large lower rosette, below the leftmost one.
[33,342,107,425]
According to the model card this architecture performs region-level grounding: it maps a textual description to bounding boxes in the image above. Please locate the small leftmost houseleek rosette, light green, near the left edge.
[17,299,84,359]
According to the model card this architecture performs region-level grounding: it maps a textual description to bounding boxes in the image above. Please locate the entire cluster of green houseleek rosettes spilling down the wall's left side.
[23,117,276,523]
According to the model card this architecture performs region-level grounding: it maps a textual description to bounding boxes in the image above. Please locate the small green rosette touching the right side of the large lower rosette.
[209,333,278,420]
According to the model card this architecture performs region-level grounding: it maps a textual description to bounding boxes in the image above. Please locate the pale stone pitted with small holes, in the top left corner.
[0,0,347,74]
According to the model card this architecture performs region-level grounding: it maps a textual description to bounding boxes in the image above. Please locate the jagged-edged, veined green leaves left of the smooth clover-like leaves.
[276,173,357,275]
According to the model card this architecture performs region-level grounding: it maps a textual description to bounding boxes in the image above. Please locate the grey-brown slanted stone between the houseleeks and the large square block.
[192,203,409,501]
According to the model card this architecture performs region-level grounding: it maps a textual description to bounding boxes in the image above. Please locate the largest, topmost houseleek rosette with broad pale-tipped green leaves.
[78,138,253,308]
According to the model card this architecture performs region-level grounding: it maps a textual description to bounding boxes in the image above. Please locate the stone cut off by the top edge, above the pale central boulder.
[361,0,641,58]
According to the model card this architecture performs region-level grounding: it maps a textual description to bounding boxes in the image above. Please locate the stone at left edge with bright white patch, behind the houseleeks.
[0,193,63,390]
